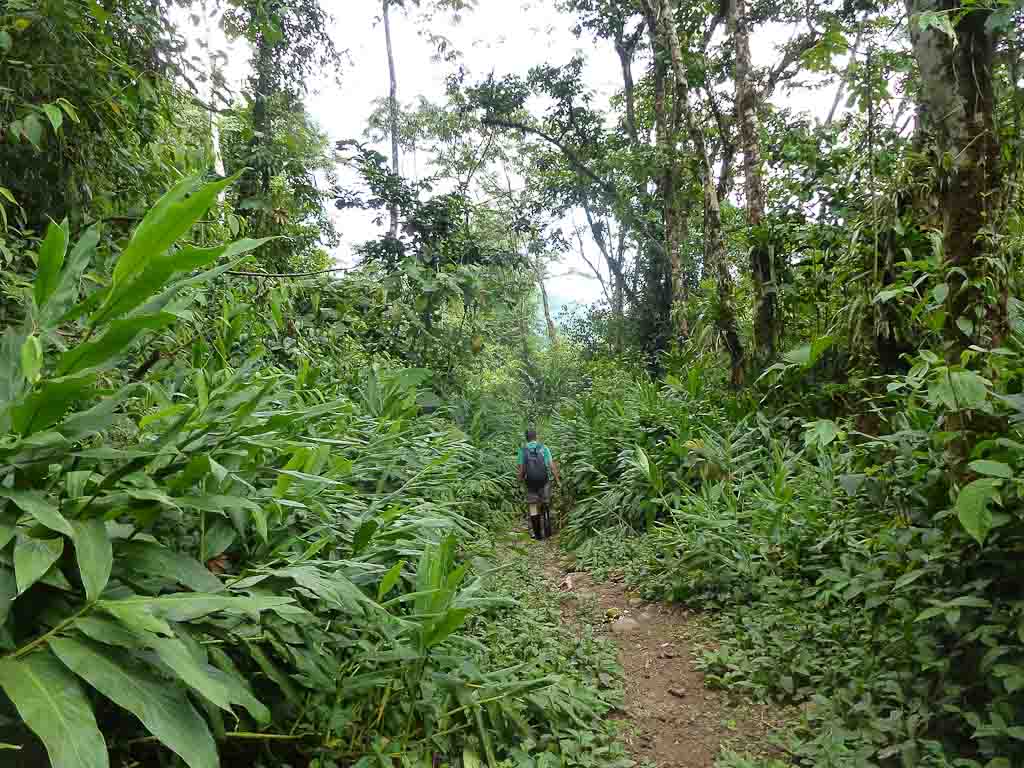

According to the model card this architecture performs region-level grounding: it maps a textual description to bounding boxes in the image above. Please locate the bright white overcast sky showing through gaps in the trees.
[190,0,834,303]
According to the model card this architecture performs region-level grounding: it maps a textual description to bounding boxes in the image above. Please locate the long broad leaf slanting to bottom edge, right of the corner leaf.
[50,637,218,768]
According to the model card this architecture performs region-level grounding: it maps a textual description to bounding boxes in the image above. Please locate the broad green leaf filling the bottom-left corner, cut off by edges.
[0,650,110,768]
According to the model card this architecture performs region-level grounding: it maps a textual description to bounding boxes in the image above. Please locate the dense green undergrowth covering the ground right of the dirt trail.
[557,360,1024,768]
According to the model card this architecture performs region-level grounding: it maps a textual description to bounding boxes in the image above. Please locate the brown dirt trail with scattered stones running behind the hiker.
[543,541,781,768]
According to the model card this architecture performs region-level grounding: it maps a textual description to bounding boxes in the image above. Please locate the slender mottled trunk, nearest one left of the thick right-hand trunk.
[729,0,778,364]
